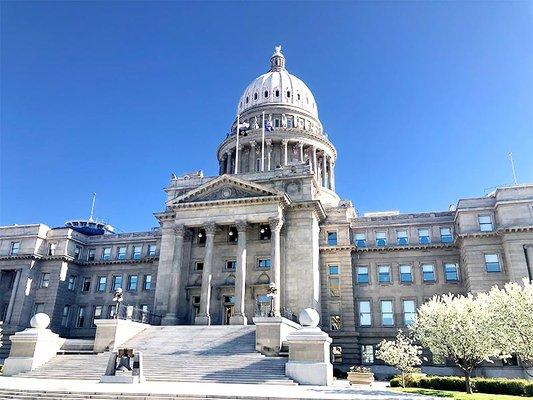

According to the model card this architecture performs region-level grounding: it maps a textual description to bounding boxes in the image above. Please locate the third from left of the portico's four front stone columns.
[229,221,248,325]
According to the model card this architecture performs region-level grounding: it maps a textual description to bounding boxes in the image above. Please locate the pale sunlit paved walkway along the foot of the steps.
[0,377,433,400]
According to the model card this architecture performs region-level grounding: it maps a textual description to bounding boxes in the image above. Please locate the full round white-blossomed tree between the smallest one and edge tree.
[412,294,501,393]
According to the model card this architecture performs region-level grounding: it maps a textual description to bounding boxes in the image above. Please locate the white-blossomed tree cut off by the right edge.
[479,278,533,376]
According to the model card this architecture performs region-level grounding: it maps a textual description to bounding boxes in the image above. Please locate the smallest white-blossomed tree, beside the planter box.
[376,329,422,387]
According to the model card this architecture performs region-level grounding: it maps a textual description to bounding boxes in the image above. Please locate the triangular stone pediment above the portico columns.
[170,175,283,205]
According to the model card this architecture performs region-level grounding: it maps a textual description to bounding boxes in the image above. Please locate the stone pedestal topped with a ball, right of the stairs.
[285,308,333,386]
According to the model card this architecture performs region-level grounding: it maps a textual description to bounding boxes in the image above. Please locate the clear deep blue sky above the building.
[0,1,533,231]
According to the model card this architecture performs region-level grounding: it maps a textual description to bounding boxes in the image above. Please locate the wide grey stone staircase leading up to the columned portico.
[14,325,295,385]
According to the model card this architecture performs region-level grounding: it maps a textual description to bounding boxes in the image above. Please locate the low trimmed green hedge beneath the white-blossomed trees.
[390,374,533,397]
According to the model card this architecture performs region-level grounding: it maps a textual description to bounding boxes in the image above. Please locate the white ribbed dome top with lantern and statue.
[237,46,318,119]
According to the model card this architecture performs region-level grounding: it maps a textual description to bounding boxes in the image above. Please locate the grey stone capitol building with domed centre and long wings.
[0,47,533,369]
